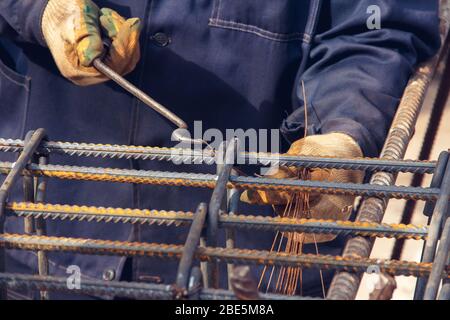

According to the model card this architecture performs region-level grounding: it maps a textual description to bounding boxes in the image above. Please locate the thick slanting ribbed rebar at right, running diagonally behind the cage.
[327,32,448,300]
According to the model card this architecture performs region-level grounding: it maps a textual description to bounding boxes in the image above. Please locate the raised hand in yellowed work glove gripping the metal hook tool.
[42,0,141,86]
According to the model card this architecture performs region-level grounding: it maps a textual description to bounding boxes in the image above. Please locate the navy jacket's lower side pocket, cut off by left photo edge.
[0,59,31,139]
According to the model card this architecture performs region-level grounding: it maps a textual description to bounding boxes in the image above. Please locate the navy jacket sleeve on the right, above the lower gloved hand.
[281,0,440,156]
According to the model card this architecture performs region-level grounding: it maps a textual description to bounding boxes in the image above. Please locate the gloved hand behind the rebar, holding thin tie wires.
[241,133,364,243]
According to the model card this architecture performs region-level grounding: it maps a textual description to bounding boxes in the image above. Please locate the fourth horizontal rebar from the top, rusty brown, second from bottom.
[0,234,444,278]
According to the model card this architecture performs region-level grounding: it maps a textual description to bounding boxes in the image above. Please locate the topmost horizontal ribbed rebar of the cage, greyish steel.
[0,139,436,173]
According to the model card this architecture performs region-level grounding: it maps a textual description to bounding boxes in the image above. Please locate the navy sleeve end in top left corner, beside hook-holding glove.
[0,0,48,46]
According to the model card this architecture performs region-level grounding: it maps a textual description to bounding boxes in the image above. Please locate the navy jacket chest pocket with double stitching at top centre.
[209,0,310,42]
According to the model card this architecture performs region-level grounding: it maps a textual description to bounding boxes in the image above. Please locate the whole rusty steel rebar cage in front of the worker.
[0,1,450,300]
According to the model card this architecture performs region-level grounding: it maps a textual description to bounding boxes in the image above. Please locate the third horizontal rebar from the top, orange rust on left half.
[7,202,428,240]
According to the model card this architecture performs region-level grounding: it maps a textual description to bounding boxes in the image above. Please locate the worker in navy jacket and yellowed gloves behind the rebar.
[0,0,439,299]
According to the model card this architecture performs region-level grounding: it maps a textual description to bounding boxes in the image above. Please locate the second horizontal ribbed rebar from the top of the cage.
[0,162,439,200]
